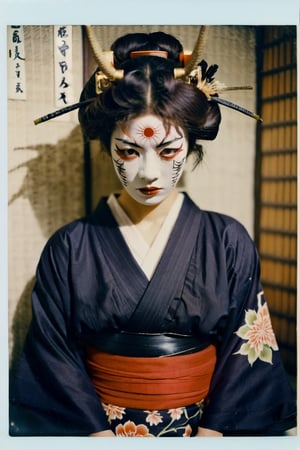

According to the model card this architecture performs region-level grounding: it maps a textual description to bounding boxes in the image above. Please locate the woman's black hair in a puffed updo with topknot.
[79,32,221,165]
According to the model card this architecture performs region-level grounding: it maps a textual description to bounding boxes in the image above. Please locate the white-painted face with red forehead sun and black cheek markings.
[111,114,188,205]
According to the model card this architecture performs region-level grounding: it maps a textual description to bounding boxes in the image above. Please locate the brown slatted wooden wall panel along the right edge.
[255,26,297,375]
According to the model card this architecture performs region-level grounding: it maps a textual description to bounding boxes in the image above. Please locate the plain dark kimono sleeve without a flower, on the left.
[10,229,109,436]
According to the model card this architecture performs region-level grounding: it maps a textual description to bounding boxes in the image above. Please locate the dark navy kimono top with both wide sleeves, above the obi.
[10,195,296,436]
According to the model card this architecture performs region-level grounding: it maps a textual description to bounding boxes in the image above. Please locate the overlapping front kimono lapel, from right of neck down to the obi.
[127,196,201,333]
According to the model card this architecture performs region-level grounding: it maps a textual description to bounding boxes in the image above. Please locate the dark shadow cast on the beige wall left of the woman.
[9,126,84,370]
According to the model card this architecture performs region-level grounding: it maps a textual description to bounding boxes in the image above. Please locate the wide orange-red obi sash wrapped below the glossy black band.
[86,345,216,410]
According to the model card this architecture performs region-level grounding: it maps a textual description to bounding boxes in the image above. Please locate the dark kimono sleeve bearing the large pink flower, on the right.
[200,221,296,435]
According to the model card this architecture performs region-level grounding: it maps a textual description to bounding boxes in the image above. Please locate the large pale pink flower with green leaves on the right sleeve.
[235,292,278,366]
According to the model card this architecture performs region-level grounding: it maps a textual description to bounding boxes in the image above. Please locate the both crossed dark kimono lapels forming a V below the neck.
[94,196,201,333]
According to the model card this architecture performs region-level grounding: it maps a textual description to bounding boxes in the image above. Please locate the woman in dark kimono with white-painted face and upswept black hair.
[11,27,295,437]
